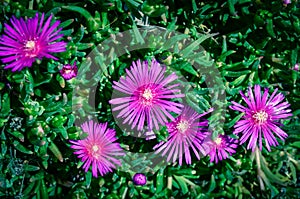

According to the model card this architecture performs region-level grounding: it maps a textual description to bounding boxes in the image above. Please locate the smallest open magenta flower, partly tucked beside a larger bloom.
[205,134,238,163]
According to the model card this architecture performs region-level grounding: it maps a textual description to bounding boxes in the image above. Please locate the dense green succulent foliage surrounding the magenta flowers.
[0,0,300,199]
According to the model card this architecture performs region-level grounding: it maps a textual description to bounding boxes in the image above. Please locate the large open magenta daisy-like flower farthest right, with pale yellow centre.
[230,85,292,151]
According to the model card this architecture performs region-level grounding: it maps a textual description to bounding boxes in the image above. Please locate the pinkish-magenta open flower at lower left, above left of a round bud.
[70,120,124,178]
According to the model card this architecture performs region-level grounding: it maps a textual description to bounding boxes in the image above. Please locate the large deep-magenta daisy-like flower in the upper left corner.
[0,13,66,72]
